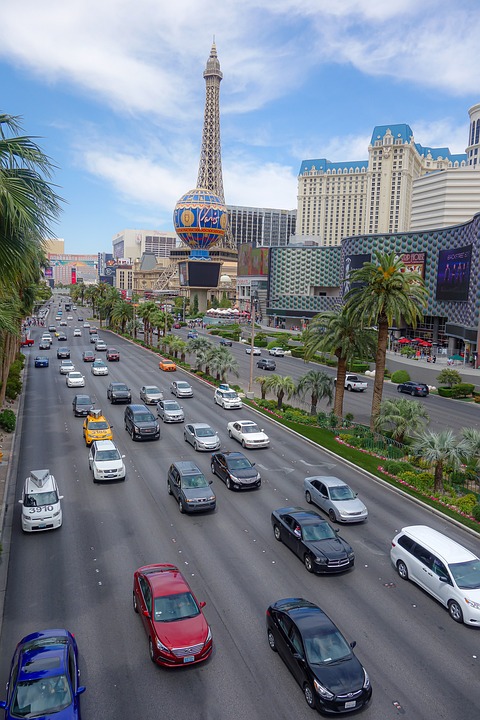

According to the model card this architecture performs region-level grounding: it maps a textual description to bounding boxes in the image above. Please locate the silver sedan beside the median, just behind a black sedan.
[303,475,368,523]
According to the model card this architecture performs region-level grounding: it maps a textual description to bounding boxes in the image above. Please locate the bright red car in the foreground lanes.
[133,563,213,667]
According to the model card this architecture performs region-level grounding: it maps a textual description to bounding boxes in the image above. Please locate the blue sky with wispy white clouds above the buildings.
[0,0,480,254]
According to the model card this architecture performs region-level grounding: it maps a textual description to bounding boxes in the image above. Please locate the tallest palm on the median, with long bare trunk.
[345,252,428,430]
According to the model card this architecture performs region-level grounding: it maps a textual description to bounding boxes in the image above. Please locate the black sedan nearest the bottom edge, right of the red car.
[267,598,372,714]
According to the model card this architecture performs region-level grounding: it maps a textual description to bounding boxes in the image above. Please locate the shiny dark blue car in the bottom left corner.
[0,630,85,720]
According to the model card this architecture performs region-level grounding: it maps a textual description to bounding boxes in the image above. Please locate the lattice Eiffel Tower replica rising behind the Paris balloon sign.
[197,42,236,248]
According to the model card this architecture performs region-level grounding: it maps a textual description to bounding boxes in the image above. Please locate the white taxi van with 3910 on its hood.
[19,470,63,532]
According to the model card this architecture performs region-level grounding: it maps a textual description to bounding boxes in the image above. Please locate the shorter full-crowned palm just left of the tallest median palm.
[304,308,377,417]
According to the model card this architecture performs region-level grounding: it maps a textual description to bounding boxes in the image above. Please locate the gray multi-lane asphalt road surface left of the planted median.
[0,323,480,720]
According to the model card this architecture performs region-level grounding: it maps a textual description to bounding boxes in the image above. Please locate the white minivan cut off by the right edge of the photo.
[390,525,480,626]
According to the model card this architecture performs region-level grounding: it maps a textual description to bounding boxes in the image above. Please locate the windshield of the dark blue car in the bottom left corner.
[12,675,72,718]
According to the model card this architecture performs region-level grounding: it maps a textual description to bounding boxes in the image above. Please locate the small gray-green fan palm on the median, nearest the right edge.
[412,430,467,493]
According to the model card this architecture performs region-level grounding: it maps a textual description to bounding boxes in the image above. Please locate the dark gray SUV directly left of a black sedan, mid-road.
[167,460,217,513]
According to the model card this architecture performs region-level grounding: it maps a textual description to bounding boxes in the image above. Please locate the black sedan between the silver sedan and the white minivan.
[272,507,355,574]
